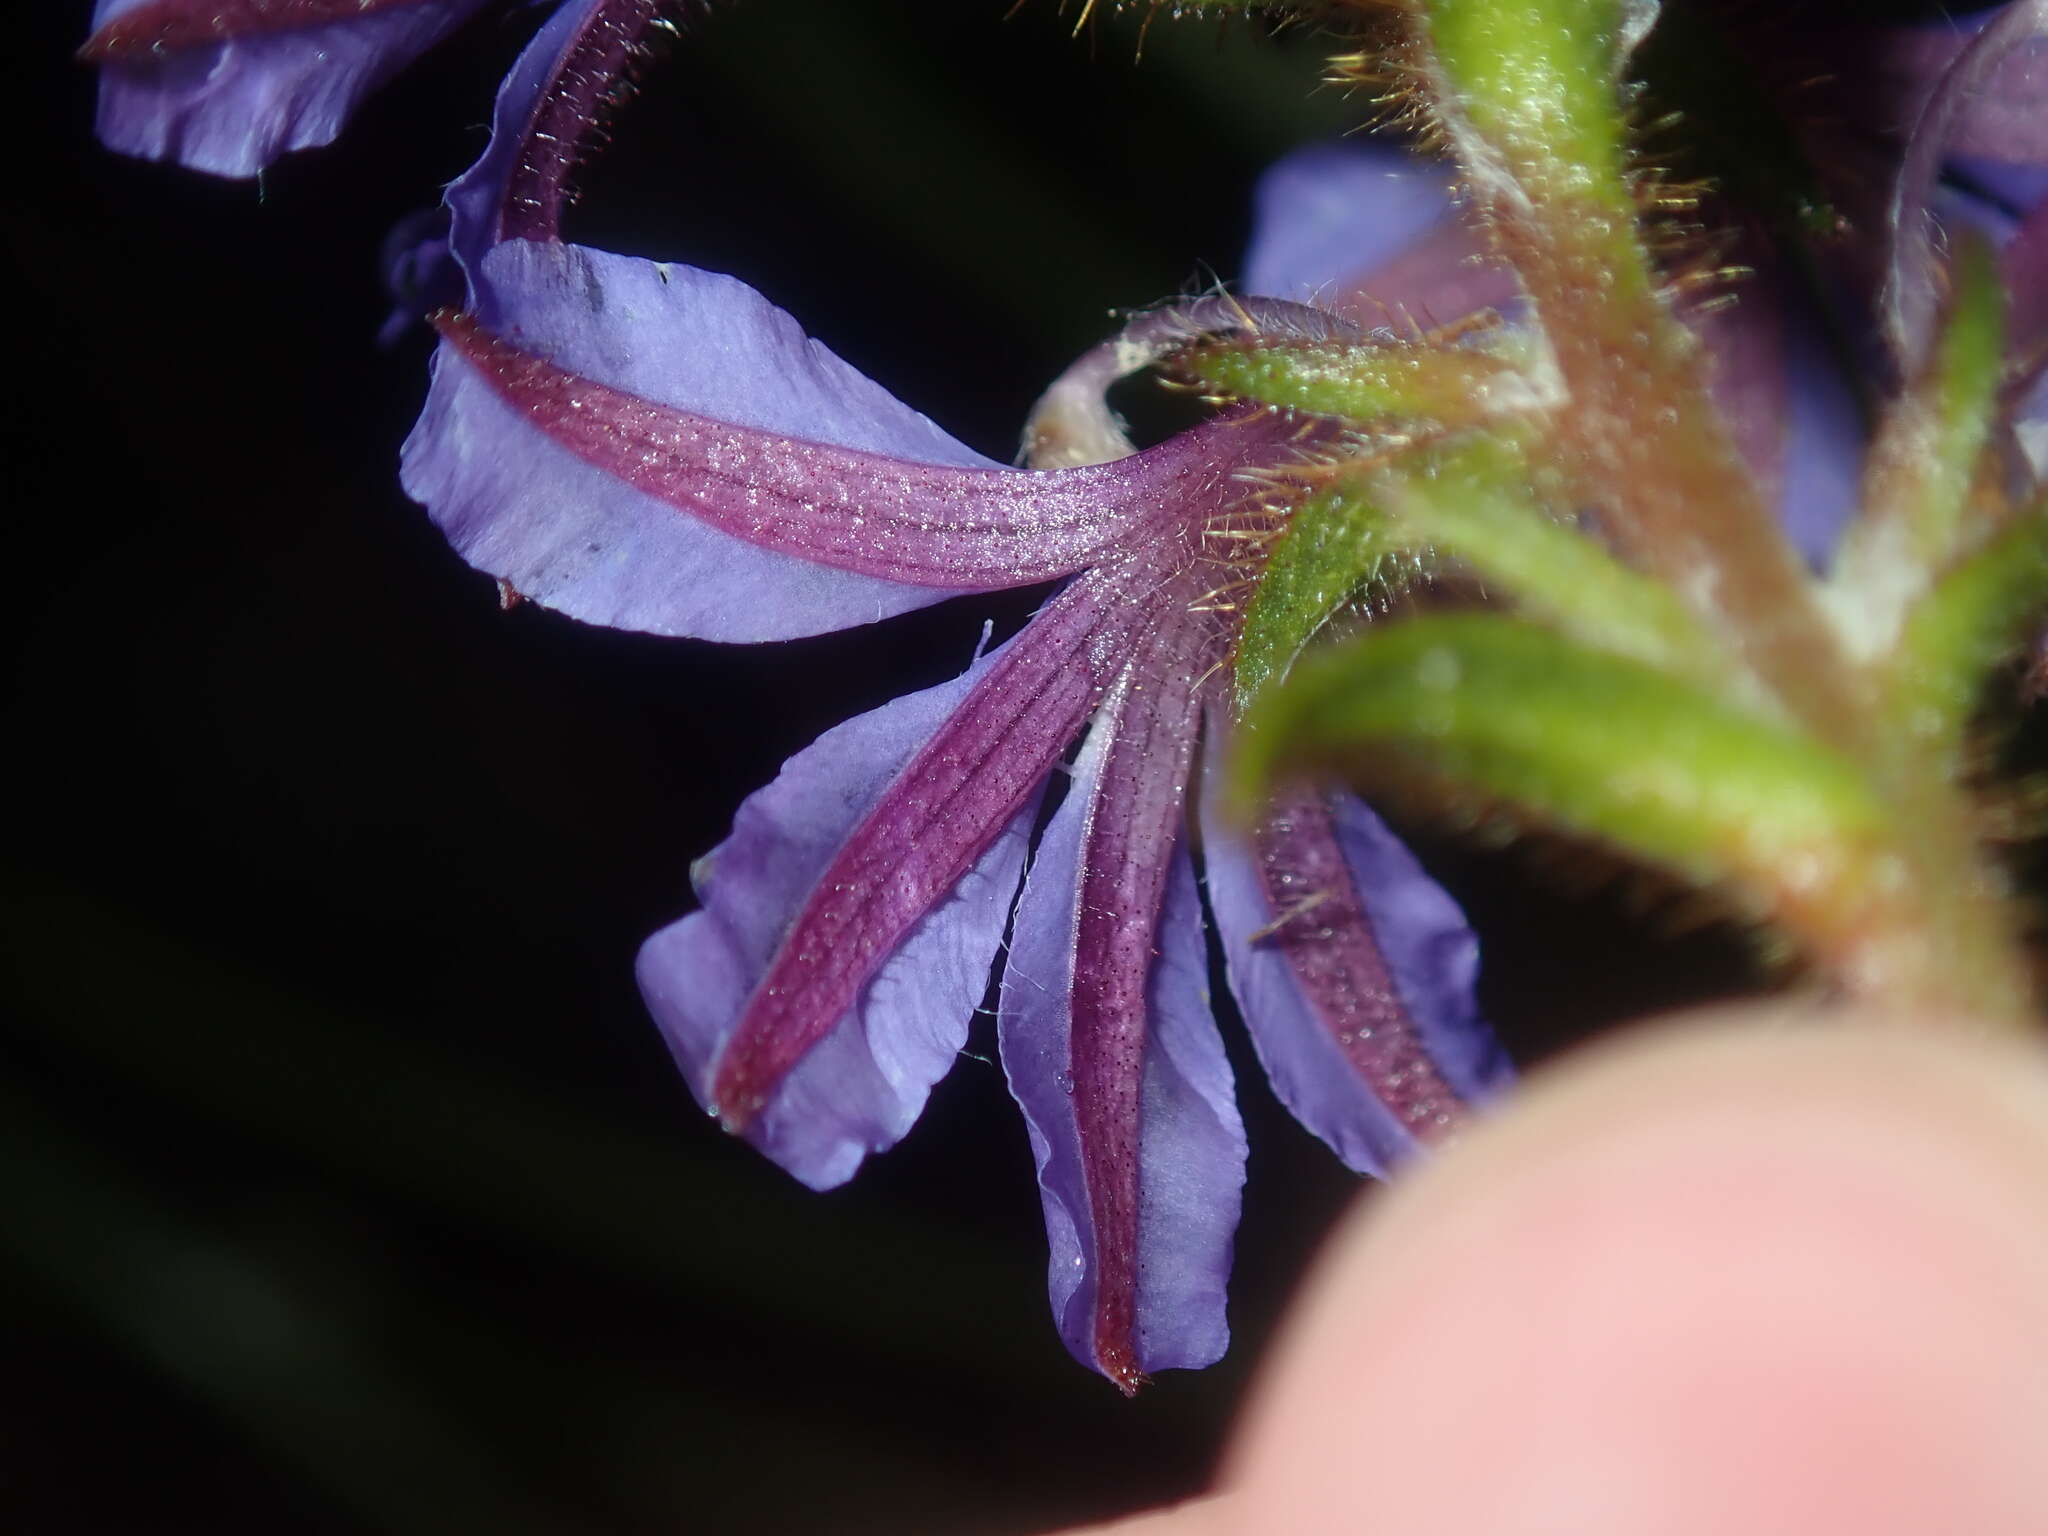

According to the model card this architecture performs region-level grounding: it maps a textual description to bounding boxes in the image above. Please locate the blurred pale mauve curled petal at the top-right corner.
[1882,0,2048,375]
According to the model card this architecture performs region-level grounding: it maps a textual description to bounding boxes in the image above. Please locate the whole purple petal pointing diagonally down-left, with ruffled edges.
[641,575,1133,1186]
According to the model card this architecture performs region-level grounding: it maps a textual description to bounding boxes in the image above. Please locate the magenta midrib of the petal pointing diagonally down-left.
[711,573,1133,1130]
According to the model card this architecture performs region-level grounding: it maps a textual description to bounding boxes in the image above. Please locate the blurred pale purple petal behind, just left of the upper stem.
[1243,145,1518,326]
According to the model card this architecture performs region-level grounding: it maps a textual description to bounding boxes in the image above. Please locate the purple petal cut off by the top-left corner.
[84,0,485,176]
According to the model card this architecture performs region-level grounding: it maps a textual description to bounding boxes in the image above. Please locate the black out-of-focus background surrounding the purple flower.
[0,0,1761,1536]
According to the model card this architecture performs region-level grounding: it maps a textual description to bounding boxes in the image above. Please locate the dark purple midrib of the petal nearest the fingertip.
[1253,791,1466,1141]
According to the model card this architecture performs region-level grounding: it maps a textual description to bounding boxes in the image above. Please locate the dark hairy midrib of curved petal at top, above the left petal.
[498,0,662,240]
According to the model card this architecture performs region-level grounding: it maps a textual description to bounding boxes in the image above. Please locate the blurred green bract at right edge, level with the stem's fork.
[1888,502,2048,752]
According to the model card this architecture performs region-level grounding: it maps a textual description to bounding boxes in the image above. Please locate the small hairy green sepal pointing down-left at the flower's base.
[1237,487,1415,713]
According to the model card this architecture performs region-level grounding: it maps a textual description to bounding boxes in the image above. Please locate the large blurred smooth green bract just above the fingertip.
[1233,612,1884,907]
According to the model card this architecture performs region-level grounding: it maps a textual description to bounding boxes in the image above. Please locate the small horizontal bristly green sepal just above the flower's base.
[1171,338,1544,428]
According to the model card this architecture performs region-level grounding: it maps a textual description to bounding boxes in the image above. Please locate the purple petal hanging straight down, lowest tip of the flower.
[999,598,1245,1393]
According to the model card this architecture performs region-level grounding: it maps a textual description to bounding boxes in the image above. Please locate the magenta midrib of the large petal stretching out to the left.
[436,315,1239,590]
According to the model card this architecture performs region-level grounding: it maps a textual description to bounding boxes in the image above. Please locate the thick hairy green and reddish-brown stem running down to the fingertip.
[1417,0,2034,1024]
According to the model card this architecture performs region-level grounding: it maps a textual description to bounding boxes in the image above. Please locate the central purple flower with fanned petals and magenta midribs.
[403,0,1507,1391]
